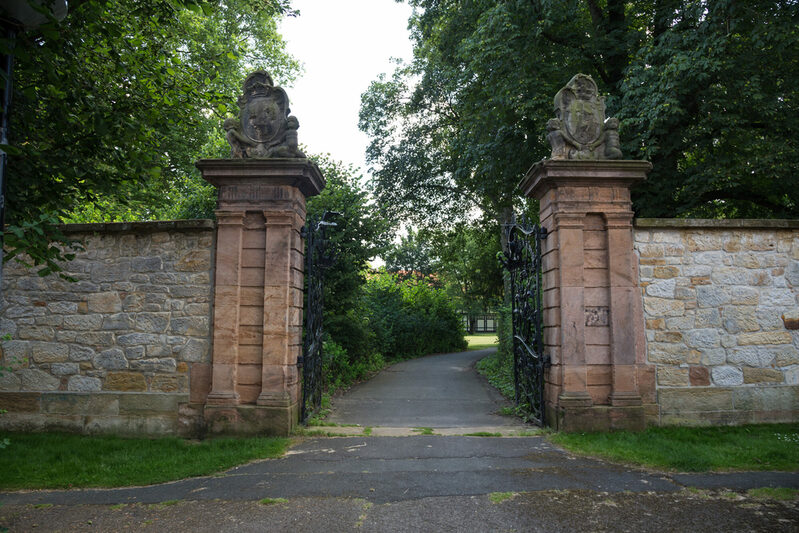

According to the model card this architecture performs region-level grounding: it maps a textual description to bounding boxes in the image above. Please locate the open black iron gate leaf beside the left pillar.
[297,211,338,423]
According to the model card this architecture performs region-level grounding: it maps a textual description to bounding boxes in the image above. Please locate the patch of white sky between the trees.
[279,0,412,174]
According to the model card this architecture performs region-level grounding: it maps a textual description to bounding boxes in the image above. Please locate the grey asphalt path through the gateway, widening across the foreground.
[0,352,799,533]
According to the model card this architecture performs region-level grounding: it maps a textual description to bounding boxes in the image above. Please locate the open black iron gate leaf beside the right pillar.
[503,217,549,425]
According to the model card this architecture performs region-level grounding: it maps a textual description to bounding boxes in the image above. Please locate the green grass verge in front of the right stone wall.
[550,424,799,472]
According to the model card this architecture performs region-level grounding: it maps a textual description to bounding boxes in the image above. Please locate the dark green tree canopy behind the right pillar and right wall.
[360,0,799,225]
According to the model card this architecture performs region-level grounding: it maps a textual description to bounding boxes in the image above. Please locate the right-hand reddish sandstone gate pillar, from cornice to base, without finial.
[520,159,654,431]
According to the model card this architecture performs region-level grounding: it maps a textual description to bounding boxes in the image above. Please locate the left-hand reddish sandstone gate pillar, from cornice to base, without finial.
[197,159,324,435]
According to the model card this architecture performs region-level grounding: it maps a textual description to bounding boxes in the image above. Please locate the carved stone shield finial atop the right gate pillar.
[547,74,622,159]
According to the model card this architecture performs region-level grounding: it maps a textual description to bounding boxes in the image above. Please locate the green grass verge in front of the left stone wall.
[0,433,289,490]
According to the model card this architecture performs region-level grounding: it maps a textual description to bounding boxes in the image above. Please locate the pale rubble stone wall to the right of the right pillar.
[635,219,799,424]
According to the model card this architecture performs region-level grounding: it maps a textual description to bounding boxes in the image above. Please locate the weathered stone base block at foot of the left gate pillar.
[203,403,299,437]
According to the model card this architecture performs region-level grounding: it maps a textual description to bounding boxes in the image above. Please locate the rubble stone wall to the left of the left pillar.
[0,220,214,435]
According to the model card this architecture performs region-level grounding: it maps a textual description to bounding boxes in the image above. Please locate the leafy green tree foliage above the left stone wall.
[0,0,298,272]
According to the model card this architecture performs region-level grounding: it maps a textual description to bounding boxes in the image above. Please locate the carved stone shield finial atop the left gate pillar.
[224,70,305,159]
